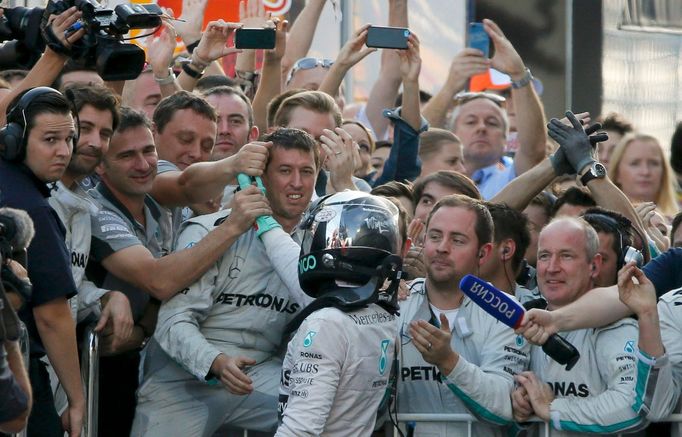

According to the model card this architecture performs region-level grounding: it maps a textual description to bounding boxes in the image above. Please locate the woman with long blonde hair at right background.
[609,134,678,217]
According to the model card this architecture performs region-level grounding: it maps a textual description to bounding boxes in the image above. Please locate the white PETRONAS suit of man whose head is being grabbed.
[132,211,309,437]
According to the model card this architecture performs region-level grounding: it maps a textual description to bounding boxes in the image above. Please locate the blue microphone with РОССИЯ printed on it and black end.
[459,275,580,371]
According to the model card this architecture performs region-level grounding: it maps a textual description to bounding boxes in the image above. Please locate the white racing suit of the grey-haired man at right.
[531,319,644,436]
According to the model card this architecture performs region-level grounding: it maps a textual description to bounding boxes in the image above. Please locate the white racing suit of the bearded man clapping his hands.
[398,279,530,437]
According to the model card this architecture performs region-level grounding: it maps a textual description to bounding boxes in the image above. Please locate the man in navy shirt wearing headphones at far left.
[0,87,85,437]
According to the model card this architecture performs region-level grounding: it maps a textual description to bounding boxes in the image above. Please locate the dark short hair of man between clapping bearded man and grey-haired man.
[486,202,530,276]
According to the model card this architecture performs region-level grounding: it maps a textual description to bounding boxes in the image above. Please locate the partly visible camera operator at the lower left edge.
[0,258,31,433]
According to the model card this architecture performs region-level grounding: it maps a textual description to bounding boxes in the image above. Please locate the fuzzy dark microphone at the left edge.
[0,208,35,267]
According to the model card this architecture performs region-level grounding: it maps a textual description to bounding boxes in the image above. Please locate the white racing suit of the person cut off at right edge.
[633,288,682,437]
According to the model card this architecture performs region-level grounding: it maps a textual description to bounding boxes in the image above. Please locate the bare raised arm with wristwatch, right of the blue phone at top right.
[483,19,546,176]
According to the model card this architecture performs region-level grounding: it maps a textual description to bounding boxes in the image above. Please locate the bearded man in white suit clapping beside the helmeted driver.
[398,194,529,436]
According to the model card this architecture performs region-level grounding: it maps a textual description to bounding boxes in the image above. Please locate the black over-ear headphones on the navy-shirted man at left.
[0,86,61,162]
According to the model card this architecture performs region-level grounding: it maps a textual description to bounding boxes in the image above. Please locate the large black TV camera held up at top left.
[43,0,163,80]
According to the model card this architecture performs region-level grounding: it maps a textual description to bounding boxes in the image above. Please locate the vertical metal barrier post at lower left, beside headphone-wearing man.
[81,324,99,437]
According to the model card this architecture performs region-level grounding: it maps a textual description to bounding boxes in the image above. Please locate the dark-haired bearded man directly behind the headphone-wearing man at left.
[48,85,132,353]
